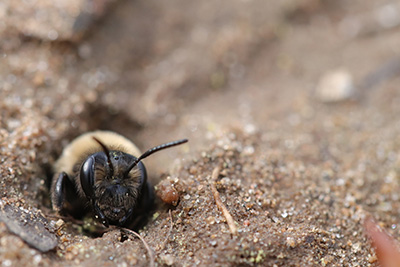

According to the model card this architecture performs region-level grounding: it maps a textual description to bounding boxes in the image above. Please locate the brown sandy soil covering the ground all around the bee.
[0,0,400,266]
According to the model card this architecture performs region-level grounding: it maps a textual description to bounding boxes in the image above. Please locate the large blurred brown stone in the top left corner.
[0,0,116,41]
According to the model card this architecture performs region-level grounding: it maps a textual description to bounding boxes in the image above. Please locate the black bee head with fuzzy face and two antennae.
[80,137,187,227]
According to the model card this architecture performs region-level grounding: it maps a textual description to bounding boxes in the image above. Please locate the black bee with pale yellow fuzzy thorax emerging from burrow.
[51,131,188,229]
